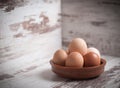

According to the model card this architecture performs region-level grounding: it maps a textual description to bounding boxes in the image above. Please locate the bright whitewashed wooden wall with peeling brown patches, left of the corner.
[0,0,61,66]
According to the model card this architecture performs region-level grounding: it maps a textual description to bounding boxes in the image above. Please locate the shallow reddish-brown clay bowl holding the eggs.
[50,59,106,79]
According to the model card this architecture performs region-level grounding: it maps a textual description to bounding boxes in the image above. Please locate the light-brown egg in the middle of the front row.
[65,52,84,68]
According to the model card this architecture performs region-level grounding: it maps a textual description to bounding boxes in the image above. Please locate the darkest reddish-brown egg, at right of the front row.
[84,52,100,67]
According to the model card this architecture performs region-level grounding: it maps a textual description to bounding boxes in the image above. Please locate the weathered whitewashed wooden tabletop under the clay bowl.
[0,55,120,88]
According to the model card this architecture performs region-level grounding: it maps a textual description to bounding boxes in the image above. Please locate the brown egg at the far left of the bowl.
[53,49,68,65]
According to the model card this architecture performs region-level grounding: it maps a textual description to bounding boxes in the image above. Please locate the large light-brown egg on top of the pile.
[68,38,87,55]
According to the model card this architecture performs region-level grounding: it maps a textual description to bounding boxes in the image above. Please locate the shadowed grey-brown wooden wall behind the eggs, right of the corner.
[61,0,120,56]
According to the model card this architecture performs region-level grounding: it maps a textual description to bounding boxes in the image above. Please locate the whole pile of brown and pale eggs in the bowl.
[52,38,101,68]
